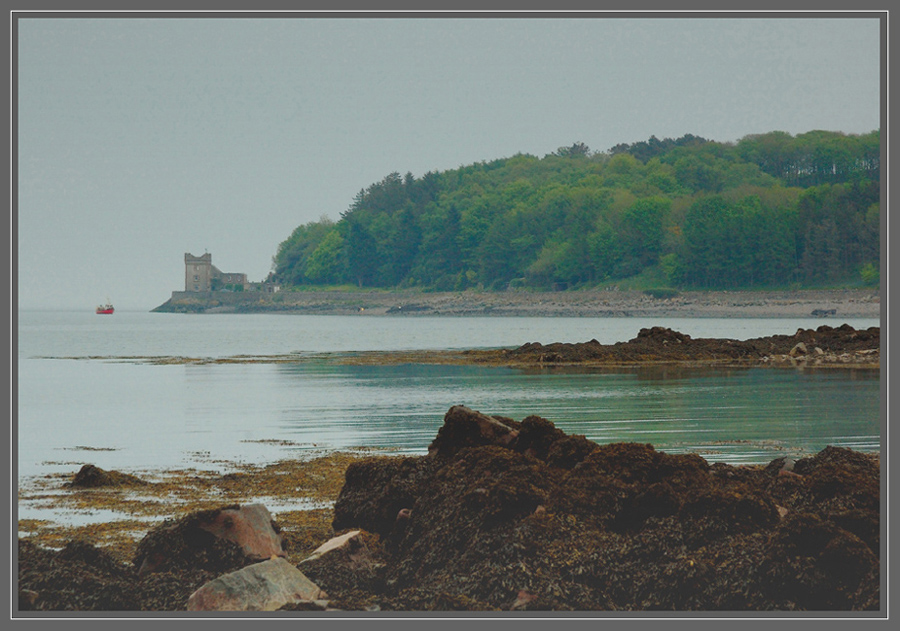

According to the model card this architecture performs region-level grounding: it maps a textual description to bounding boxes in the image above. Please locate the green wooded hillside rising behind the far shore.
[274,131,880,290]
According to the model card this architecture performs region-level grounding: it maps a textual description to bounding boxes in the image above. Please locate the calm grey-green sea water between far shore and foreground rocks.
[16,312,881,479]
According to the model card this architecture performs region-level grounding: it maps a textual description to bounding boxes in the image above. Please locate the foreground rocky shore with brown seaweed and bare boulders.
[18,406,882,616]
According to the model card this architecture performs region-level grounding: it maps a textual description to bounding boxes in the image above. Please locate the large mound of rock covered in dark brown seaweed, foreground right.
[328,408,881,610]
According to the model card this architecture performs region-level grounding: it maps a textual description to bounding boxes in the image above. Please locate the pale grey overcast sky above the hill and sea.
[15,14,880,310]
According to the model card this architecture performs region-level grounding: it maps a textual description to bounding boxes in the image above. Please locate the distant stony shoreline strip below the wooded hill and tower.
[153,289,881,318]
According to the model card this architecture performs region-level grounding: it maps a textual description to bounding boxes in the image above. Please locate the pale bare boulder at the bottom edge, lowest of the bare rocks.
[187,557,327,611]
